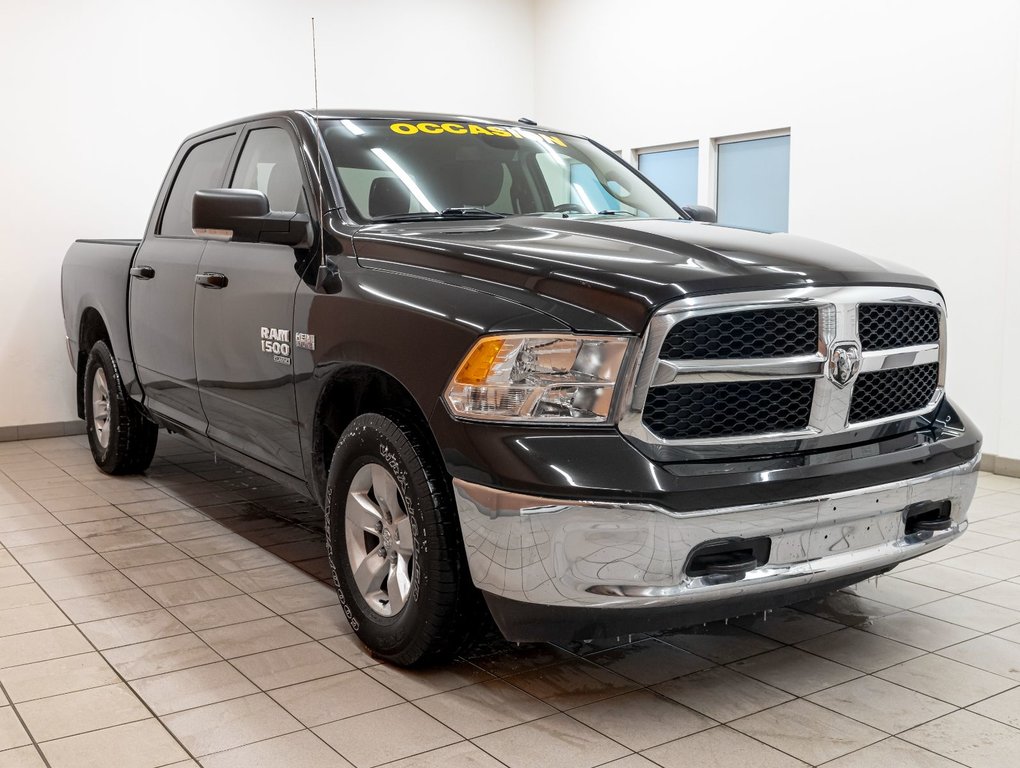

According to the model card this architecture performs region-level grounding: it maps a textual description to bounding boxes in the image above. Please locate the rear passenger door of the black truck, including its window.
[128,130,238,432]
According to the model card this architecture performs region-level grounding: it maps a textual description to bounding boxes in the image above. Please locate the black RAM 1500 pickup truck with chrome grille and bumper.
[62,110,981,665]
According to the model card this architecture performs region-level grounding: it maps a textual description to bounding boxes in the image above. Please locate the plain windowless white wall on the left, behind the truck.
[0,0,533,426]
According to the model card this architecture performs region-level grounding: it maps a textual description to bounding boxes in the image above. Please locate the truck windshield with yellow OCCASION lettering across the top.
[321,119,680,221]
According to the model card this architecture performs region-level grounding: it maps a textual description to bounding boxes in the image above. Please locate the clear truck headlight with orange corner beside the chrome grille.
[446,334,629,422]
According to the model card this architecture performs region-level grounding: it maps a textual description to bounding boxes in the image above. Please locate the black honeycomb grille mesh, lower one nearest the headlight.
[644,378,815,440]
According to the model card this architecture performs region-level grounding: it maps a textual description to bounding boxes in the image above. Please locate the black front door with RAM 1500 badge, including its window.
[193,120,310,476]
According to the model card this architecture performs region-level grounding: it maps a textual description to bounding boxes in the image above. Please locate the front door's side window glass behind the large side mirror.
[231,127,308,213]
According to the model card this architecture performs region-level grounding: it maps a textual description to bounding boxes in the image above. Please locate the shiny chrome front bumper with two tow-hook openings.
[454,457,980,608]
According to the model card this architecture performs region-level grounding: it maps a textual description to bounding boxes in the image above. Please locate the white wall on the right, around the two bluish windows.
[534,0,1020,458]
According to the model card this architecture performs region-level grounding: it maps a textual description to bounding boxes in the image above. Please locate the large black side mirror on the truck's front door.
[192,190,312,248]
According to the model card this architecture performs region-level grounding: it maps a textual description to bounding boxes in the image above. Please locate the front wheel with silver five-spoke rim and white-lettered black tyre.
[325,413,483,666]
